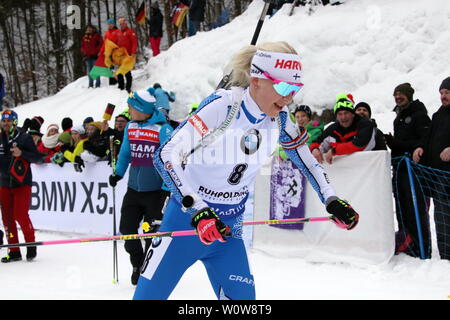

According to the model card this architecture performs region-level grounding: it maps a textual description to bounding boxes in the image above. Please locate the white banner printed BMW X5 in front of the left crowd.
[30,161,128,235]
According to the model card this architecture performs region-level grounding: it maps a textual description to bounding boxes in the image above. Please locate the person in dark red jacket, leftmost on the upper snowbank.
[81,25,103,88]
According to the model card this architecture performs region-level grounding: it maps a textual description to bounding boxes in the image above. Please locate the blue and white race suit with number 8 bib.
[134,89,335,300]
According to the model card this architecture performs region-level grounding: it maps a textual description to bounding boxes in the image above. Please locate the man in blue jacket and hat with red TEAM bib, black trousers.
[109,89,173,285]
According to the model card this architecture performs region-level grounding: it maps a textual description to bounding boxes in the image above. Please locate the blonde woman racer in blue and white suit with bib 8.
[132,42,358,300]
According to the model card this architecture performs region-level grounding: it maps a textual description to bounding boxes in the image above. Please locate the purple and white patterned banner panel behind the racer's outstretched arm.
[270,157,306,230]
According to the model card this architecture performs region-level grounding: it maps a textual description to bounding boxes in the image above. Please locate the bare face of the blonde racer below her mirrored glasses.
[250,78,294,118]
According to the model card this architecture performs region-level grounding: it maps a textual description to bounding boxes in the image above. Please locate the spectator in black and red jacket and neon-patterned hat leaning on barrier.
[309,94,376,164]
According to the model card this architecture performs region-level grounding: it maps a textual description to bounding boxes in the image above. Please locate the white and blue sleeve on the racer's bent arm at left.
[153,93,225,214]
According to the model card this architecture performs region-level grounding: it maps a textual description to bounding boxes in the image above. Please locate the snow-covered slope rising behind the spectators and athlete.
[16,0,450,132]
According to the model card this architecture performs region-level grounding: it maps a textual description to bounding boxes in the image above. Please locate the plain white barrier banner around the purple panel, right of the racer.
[253,151,395,264]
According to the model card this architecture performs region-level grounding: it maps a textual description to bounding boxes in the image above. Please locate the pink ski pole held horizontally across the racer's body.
[0,216,332,248]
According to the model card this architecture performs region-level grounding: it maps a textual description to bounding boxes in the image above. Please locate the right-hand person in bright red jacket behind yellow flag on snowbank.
[116,18,138,93]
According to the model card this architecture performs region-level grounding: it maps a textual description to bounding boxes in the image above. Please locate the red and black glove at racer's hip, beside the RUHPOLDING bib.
[191,207,231,245]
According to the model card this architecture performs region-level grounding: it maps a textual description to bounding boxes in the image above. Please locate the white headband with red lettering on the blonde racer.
[250,50,302,83]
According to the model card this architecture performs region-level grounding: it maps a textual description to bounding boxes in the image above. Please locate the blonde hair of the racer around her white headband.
[230,41,297,87]
